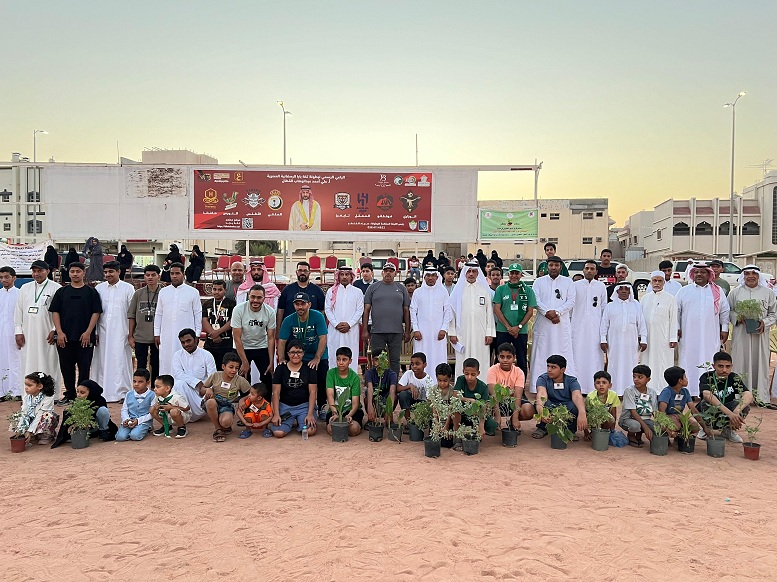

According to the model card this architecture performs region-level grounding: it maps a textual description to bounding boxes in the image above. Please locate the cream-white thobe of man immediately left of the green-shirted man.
[446,282,496,382]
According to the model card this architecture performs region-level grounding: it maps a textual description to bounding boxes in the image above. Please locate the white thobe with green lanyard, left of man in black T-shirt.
[14,279,61,394]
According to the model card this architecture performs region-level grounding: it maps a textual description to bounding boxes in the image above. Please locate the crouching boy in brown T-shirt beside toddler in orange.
[202,352,251,443]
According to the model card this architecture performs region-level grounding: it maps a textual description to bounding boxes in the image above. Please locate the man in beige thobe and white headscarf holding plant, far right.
[728,265,777,404]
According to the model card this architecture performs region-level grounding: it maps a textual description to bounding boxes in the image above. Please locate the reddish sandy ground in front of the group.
[0,403,777,582]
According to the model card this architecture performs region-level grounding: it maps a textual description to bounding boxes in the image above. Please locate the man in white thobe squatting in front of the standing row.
[171,330,216,422]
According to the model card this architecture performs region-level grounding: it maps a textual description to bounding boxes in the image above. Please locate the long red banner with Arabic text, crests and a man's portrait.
[192,169,432,234]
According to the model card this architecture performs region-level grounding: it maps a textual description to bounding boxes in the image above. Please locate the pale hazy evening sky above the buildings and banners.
[0,0,777,225]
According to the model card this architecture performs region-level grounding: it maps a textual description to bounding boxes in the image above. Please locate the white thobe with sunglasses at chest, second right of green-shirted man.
[572,279,607,394]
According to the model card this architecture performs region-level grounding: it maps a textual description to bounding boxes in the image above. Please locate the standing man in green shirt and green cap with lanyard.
[494,263,537,374]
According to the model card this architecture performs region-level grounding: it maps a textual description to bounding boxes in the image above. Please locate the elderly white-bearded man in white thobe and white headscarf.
[639,271,677,394]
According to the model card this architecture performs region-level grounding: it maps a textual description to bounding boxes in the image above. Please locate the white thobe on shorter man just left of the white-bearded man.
[599,293,644,396]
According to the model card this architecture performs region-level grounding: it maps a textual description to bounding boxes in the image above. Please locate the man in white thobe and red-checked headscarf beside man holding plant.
[675,262,729,396]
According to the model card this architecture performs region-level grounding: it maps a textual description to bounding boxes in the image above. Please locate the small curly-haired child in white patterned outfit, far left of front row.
[13,372,59,445]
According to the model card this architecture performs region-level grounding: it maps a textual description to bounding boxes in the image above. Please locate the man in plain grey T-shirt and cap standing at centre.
[362,262,410,374]
